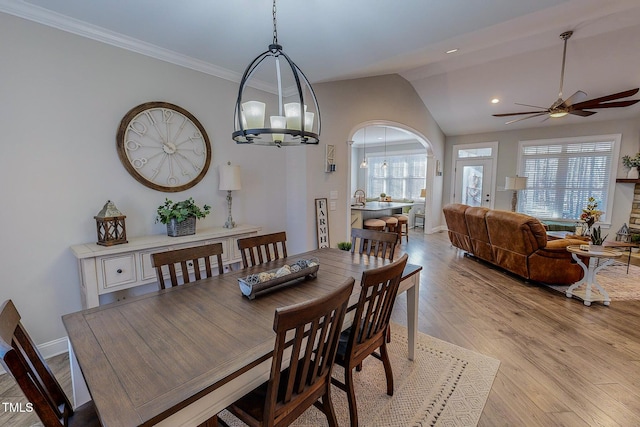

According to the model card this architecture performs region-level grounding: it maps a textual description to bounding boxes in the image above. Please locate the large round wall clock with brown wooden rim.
[116,102,211,192]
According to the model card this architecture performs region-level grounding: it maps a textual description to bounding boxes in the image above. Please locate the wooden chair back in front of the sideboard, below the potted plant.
[151,243,224,289]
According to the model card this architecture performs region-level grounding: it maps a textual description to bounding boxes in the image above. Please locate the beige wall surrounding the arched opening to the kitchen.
[306,74,445,247]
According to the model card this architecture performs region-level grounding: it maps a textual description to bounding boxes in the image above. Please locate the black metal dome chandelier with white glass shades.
[232,0,320,147]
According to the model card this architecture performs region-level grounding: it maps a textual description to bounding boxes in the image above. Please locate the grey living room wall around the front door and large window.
[443,118,640,234]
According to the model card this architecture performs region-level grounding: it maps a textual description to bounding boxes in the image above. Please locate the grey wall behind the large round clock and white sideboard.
[0,13,290,343]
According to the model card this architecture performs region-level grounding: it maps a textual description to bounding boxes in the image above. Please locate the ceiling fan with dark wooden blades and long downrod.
[493,31,640,125]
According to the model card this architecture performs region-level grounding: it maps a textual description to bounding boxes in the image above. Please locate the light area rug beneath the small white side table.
[549,255,640,301]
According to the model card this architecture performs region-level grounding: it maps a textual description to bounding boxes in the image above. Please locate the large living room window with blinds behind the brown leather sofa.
[518,135,620,222]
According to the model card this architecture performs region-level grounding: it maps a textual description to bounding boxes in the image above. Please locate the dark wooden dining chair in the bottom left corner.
[0,300,100,427]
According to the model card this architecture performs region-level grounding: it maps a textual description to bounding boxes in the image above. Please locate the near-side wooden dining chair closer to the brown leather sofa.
[331,254,408,427]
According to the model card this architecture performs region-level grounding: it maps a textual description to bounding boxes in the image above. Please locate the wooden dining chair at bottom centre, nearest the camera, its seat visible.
[227,278,355,427]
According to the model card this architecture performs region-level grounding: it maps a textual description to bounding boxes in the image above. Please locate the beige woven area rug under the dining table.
[220,324,500,427]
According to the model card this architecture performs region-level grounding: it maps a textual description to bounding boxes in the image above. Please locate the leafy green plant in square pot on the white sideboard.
[156,197,211,237]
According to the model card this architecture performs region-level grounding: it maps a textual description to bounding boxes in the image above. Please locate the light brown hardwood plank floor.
[0,229,640,427]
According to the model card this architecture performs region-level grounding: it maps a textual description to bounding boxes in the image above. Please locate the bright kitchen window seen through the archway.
[367,153,427,200]
